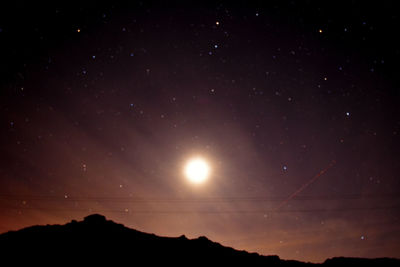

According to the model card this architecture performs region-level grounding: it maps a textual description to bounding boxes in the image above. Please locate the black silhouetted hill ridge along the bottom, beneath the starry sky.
[0,214,400,266]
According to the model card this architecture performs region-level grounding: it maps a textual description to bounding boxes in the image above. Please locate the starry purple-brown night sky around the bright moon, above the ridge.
[0,1,400,262]
